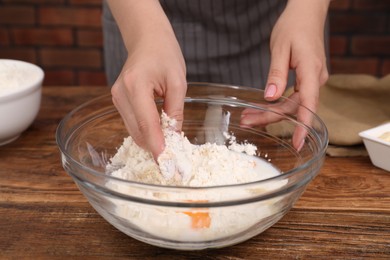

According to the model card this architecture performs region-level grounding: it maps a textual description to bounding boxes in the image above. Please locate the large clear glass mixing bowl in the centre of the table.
[56,83,328,250]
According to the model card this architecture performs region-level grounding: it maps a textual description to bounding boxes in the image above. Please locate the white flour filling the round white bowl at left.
[0,60,39,96]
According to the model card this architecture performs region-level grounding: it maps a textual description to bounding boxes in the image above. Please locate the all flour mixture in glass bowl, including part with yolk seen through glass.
[107,111,285,241]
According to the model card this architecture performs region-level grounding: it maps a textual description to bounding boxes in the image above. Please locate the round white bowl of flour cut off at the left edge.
[0,59,44,145]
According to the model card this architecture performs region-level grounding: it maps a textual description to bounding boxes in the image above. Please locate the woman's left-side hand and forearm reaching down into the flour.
[109,0,187,159]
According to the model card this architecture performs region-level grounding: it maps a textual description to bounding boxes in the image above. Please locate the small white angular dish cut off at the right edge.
[359,123,390,171]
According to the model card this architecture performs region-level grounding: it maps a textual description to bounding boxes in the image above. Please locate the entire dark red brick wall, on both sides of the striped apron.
[0,0,390,85]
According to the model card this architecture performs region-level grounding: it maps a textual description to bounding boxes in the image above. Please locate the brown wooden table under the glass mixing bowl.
[0,87,390,259]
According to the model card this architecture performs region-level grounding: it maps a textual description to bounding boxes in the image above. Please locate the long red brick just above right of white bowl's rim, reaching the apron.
[40,48,103,69]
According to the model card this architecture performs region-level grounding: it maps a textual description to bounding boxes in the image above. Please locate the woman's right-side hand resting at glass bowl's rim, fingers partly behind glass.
[241,0,330,150]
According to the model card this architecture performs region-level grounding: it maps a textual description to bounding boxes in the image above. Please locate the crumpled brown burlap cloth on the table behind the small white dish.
[285,74,390,156]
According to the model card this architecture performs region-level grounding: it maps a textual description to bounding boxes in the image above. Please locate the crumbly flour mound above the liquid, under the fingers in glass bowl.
[107,113,260,186]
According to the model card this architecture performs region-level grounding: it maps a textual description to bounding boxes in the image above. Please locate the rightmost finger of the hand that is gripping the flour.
[164,77,187,131]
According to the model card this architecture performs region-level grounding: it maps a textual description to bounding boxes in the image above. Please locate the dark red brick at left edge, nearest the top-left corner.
[0,5,35,25]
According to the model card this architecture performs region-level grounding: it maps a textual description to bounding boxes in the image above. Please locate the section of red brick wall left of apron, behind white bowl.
[0,0,106,85]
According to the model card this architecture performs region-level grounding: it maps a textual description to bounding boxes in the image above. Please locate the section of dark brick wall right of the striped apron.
[329,0,390,76]
